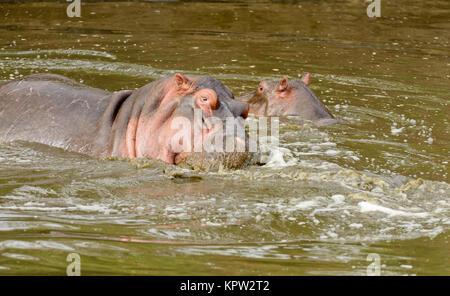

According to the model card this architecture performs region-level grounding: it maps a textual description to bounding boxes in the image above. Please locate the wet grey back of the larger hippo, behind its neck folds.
[0,74,111,151]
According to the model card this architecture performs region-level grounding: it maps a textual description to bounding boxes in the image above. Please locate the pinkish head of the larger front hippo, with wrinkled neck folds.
[113,74,249,169]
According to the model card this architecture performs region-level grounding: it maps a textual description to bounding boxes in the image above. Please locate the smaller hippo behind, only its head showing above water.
[236,73,347,126]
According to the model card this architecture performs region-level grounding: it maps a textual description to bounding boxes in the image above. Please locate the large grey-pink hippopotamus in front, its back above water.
[0,73,249,168]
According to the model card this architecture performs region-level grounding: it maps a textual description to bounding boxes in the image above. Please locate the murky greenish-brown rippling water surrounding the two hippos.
[0,0,450,275]
